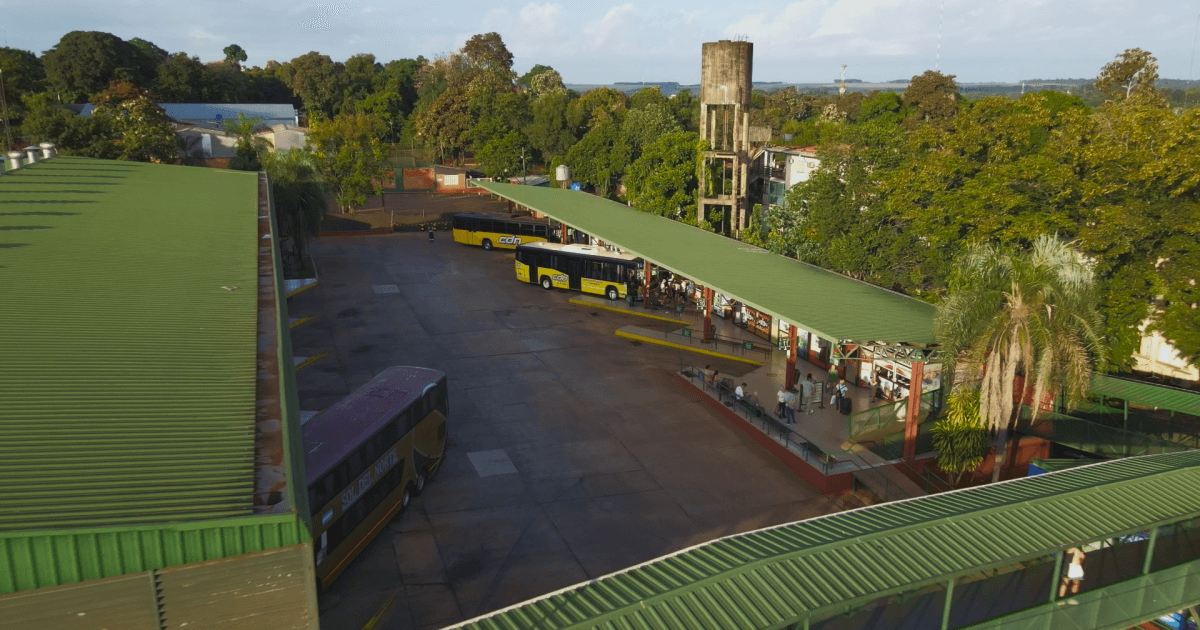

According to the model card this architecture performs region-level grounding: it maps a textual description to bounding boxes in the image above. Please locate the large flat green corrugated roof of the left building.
[0,157,258,532]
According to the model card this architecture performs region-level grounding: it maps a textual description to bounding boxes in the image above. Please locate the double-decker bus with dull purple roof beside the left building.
[302,367,450,588]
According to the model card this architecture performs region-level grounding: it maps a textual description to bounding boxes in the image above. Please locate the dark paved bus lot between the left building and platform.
[289,233,833,630]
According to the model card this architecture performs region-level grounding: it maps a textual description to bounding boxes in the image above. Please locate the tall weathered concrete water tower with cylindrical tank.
[696,40,754,234]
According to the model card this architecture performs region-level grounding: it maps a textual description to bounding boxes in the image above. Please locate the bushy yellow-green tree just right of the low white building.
[308,114,391,212]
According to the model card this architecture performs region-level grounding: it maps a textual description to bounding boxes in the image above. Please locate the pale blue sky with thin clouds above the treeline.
[0,0,1200,83]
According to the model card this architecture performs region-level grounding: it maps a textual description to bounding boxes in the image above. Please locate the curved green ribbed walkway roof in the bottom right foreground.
[454,451,1200,630]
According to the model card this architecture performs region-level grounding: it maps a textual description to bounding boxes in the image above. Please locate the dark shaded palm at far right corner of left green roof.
[263,149,329,273]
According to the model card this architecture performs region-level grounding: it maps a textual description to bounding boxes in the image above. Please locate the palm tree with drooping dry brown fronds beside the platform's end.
[935,235,1102,481]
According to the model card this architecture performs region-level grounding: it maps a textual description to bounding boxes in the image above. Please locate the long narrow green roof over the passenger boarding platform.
[475,181,934,344]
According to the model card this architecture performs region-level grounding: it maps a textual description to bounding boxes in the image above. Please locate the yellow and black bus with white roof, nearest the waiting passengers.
[516,242,642,300]
